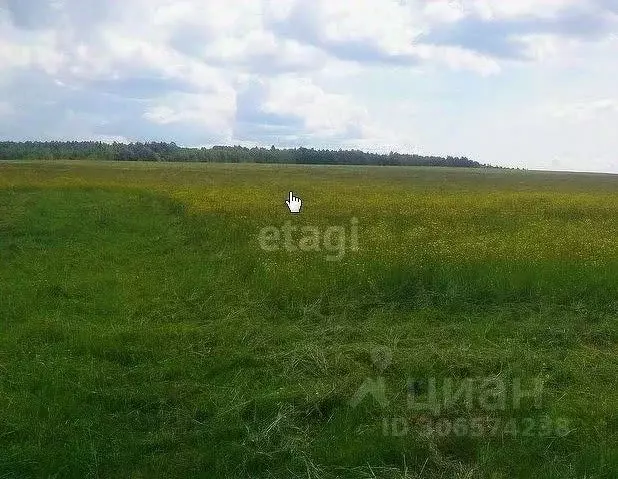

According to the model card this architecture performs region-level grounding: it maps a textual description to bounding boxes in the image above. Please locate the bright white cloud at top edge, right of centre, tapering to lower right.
[264,0,500,75]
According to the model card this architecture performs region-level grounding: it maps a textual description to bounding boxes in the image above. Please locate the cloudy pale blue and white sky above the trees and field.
[0,0,618,173]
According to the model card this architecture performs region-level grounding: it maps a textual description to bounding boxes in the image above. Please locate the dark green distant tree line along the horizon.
[0,141,489,168]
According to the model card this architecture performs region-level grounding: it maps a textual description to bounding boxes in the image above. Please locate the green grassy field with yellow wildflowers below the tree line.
[0,162,618,479]
